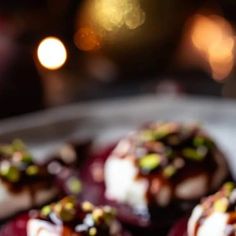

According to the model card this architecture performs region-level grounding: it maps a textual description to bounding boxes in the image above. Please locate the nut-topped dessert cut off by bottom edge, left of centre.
[27,196,127,236]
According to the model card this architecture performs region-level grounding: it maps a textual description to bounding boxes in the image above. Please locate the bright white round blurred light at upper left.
[37,37,67,70]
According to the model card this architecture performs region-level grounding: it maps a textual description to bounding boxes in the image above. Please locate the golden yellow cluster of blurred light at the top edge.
[91,0,145,31]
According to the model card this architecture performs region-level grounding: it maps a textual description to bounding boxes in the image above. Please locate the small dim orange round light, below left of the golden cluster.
[74,27,101,51]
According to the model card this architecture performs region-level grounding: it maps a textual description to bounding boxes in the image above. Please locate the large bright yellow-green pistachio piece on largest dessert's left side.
[139,154,161,171]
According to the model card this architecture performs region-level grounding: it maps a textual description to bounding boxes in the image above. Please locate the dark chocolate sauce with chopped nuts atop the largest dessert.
[111,122,227,205]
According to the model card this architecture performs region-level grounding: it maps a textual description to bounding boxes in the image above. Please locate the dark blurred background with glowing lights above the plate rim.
[0,0,236,118]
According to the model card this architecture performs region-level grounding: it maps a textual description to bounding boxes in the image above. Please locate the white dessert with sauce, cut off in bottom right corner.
[189,182,236,236]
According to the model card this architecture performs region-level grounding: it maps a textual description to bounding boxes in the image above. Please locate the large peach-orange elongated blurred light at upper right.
[191,15,235,80]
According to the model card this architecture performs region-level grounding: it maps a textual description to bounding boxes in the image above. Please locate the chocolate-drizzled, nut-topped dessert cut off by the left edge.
[0,140,58,219]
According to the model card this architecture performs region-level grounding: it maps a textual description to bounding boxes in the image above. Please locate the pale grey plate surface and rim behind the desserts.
[0,95,236,236]
